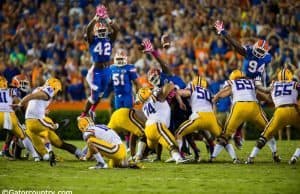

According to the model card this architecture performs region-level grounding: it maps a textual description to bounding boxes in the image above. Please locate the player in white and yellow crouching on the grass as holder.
[77,117,139,169]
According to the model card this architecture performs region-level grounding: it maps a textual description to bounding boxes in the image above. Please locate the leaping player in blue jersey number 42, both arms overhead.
[82,5,119,116]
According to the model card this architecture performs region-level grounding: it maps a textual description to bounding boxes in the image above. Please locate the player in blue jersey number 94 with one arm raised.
[214,20,272,79]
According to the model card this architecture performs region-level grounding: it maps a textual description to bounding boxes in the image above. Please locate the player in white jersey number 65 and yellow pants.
[246,69,300,164]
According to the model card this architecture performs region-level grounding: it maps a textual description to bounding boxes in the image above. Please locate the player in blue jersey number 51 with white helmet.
[110,50,139,109]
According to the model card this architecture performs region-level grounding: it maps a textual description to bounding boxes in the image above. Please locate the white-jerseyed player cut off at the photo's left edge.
[0,76,39,161]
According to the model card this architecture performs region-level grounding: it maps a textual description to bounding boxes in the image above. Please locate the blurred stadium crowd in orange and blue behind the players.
[0,0,300,100]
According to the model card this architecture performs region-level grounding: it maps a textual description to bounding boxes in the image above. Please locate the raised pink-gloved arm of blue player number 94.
[214,20,246,56]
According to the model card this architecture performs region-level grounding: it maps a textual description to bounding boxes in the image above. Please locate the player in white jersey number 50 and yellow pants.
[176,76,222,160]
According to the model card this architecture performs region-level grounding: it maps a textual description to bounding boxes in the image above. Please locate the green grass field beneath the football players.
[0,141,300,194]
